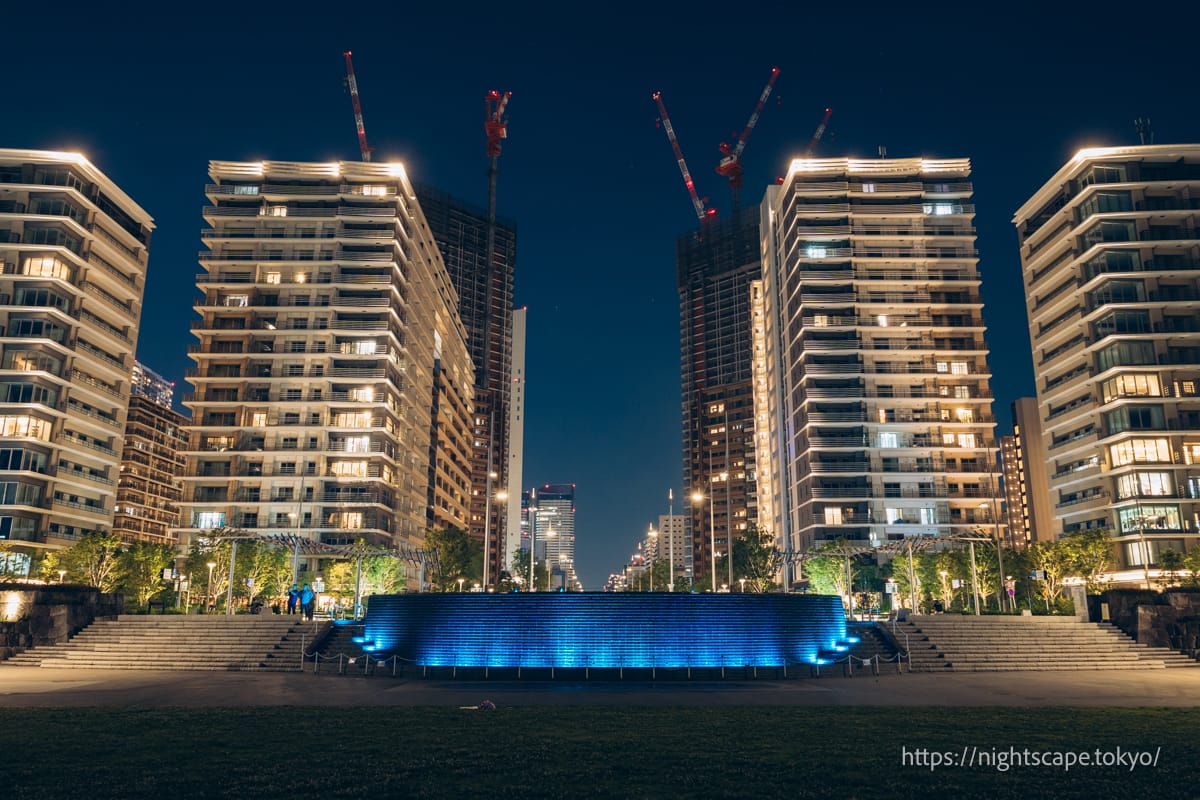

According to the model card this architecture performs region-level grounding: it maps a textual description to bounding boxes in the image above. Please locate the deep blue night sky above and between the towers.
[9,2,1200,589]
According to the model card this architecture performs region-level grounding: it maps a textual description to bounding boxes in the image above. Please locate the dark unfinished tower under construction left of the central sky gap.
[416,184,520,587]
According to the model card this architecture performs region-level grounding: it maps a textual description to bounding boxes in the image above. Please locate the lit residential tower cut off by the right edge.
[1013,144,1200,568]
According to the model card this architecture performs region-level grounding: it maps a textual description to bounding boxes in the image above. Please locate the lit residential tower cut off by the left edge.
[0,150,154,556]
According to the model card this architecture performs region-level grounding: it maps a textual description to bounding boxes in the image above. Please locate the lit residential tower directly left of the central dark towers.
[180,161,473,575]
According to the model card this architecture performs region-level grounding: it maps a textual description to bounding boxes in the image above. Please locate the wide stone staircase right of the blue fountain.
[892,614,1200,672]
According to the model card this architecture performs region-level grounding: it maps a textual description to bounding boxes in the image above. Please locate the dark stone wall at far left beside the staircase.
[0,583,125,661]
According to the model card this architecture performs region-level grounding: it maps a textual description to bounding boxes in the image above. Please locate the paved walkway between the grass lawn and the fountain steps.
[0,667,1200,708]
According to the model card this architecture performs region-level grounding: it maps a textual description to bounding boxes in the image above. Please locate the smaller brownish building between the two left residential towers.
[113,361,187,545]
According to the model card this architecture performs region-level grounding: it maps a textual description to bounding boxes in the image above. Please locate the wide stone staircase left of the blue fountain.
[0,614,329,672]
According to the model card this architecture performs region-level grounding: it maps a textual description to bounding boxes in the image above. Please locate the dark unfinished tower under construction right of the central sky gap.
[676,207,762,592]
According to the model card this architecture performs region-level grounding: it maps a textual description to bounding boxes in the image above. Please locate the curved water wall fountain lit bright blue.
[364,593,847,667]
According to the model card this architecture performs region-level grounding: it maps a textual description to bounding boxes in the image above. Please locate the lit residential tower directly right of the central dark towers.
[748,158,1001,573]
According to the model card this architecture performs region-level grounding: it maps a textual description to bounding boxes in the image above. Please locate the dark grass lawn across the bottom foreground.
[0,706,1200,800]
